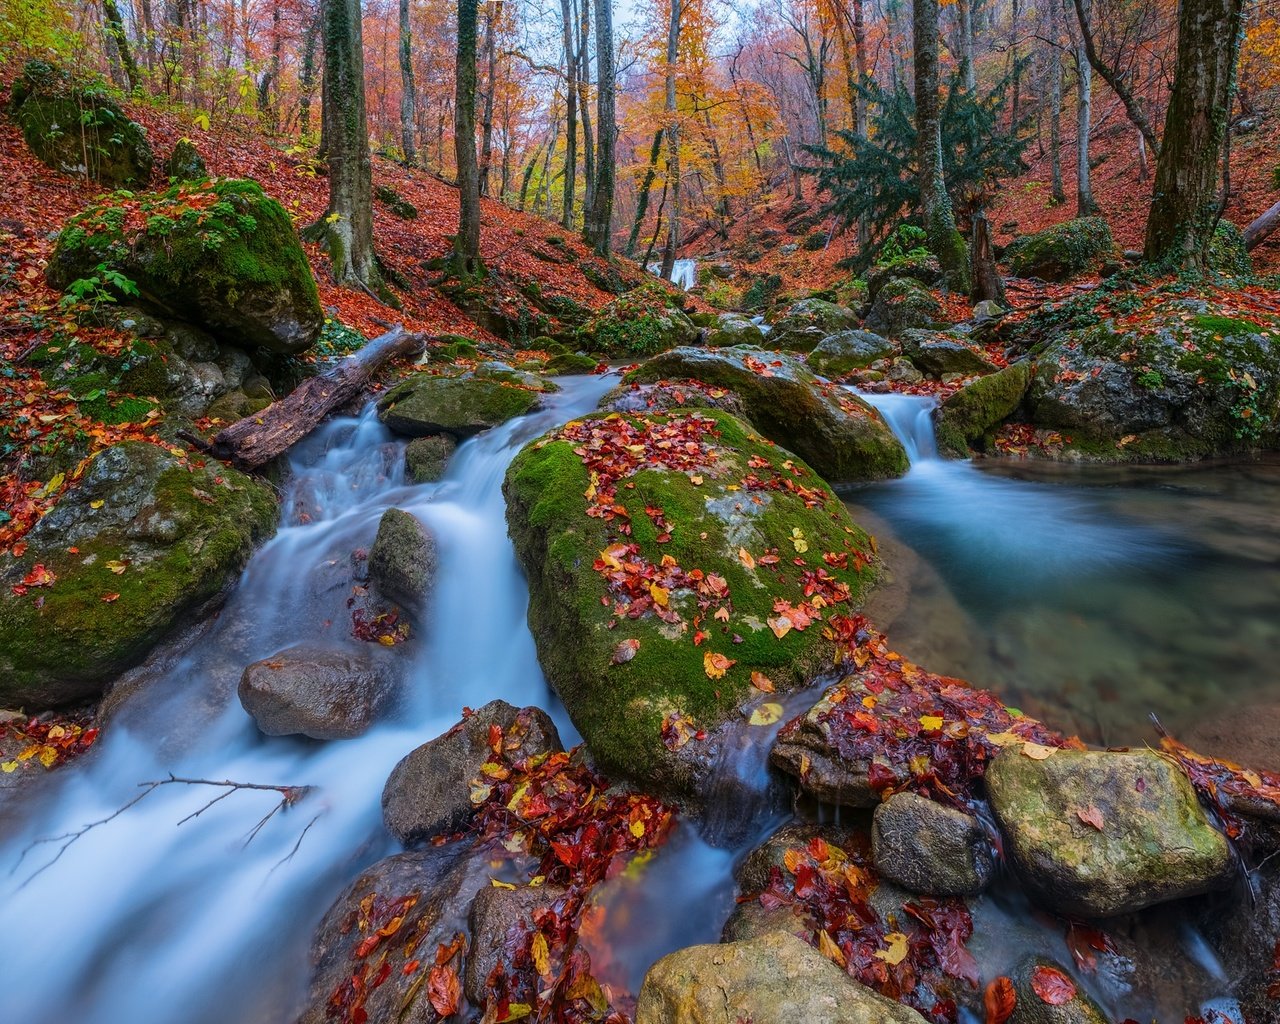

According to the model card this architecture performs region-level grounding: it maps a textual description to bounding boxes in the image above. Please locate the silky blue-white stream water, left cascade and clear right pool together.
[0,376,1264,1024]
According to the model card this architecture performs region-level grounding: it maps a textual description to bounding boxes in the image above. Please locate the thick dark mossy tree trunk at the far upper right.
[1143,0,1243,270]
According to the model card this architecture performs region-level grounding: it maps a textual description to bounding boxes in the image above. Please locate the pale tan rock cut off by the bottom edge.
[636,932,924,1024]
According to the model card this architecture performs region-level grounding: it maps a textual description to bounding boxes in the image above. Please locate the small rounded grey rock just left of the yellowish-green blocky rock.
[872,792,996,896]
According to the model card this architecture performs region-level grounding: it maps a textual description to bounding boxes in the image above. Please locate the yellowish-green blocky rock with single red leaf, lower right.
[986,748,1233,918]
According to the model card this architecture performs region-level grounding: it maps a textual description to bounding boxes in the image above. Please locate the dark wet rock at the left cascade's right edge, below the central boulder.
[383,700,563,846]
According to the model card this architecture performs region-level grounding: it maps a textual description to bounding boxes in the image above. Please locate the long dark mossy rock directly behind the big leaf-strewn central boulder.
[626,348,908,483]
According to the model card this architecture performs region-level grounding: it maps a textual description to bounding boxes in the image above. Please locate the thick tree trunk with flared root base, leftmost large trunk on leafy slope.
[315,0,394,302]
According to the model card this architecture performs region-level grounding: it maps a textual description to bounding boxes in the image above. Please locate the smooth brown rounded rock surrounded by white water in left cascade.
[239,643,396,740]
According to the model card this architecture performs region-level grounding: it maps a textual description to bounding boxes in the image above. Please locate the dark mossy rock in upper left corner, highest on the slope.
[9,60,155,186]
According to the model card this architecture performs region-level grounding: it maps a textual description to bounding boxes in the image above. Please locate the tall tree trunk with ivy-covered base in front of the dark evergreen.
[911,0,969,294]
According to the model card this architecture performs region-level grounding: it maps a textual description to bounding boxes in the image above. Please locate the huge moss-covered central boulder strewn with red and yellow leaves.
[503,410,873,796]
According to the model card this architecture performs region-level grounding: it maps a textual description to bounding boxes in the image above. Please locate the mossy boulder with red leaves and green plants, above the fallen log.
[45,179,324,353]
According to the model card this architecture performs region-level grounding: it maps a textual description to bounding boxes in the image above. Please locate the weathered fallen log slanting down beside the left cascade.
[201,324,426,470]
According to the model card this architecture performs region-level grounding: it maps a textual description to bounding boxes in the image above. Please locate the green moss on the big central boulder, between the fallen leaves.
[504,411,873,795]
